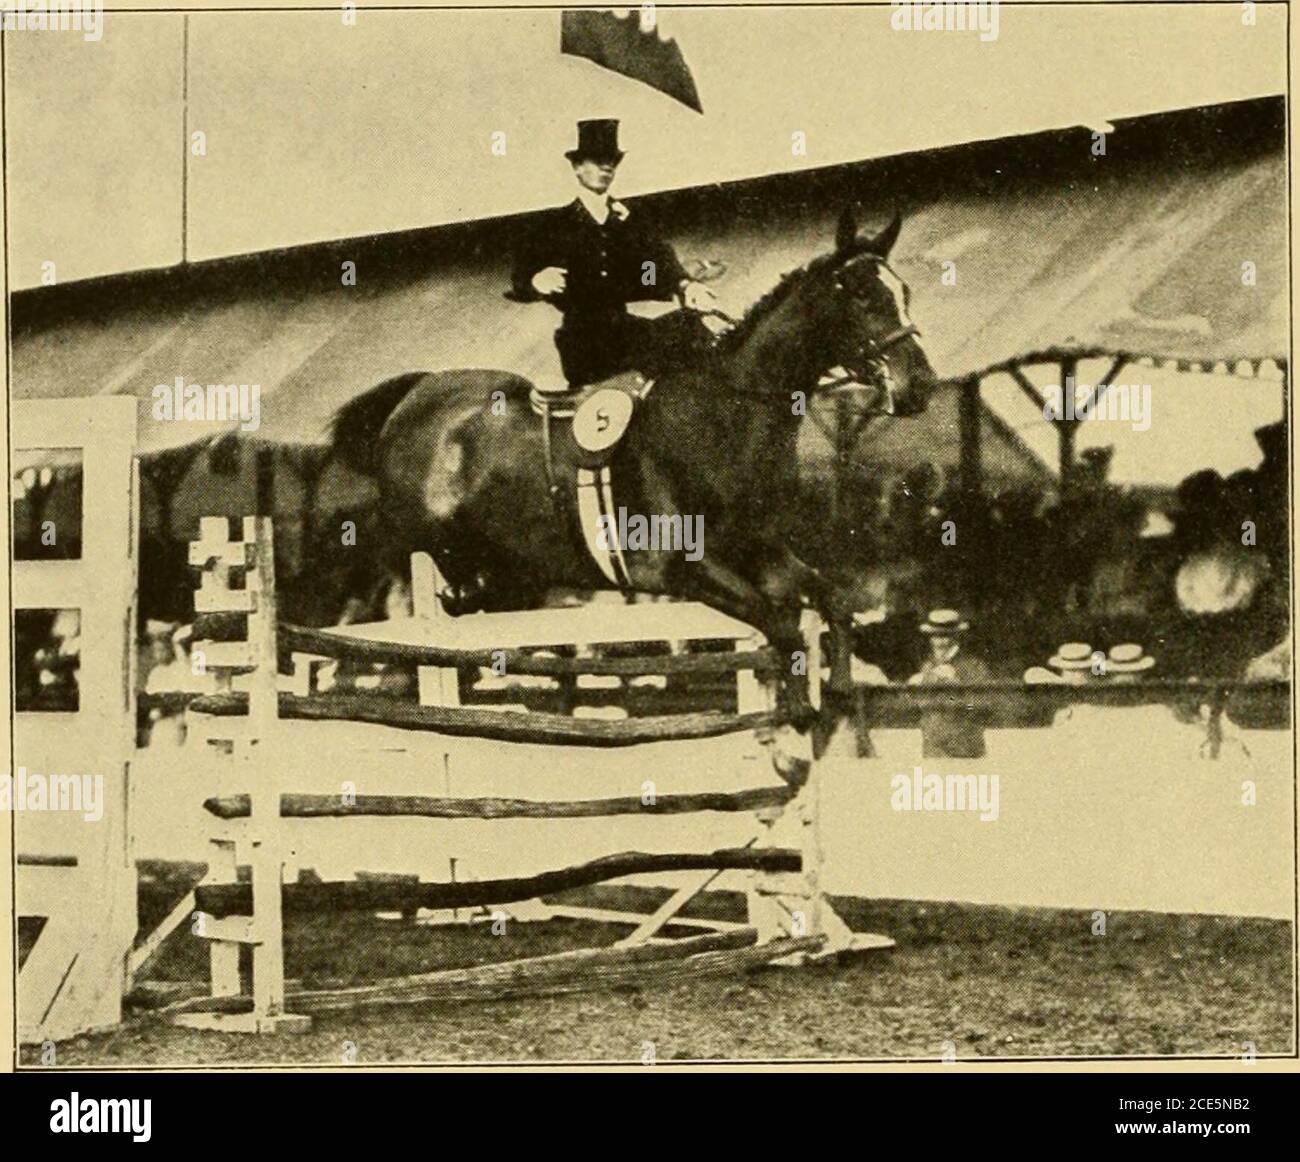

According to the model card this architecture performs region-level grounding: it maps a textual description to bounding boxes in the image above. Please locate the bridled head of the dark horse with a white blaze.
[809,207,935,416]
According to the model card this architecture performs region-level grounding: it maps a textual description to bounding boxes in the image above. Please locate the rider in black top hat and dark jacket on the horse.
[511,120,715,390]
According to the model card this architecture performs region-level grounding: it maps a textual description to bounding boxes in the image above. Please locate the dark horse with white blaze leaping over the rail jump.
[330,207,935,729]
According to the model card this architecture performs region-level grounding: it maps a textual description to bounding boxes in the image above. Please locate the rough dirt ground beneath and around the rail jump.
[22,893,1295,1067]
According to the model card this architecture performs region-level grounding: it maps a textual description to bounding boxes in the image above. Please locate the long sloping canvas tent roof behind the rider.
[12,99,1288,467]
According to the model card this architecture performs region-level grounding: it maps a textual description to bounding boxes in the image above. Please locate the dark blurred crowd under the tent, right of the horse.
[819,424,1290,681]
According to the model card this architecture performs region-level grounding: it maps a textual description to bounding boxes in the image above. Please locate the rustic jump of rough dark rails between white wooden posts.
[172,517,892,1032]
